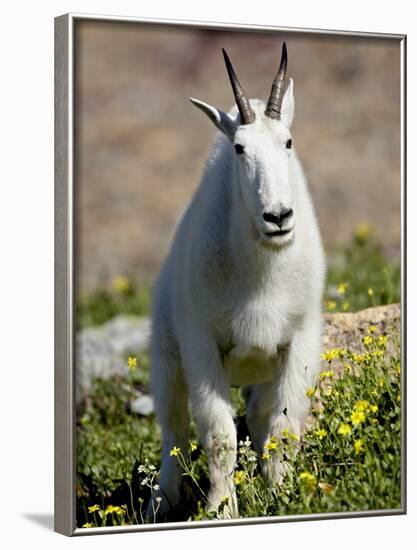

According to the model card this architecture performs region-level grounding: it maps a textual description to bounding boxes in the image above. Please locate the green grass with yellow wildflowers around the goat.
[77,230,401,527]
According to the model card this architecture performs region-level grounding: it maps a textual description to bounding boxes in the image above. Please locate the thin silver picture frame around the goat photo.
[54,13,407,536]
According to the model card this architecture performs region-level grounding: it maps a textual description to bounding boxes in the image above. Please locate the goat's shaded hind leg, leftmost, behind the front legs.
[147,349,189,522]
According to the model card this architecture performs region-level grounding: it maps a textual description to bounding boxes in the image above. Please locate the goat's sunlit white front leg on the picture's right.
[268,322,321,483]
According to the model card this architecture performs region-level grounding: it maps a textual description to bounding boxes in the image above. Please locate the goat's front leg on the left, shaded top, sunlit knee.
[182,329,238,518]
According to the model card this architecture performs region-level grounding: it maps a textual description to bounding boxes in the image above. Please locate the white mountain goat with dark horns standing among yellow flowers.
[148,43,325,519]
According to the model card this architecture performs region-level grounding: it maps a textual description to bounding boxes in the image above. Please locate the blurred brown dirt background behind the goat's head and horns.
[75,20,400,289]
